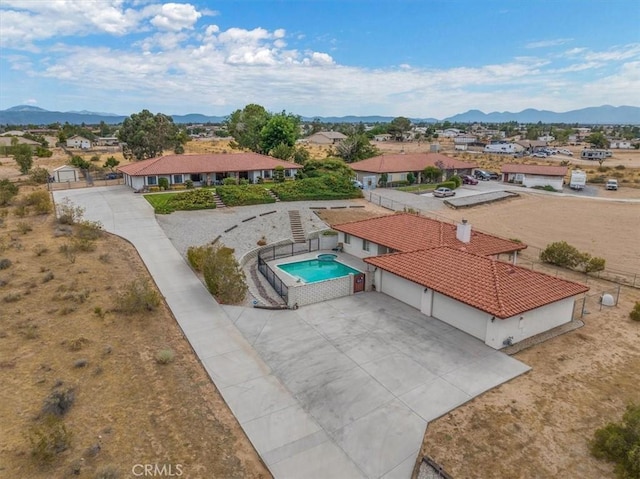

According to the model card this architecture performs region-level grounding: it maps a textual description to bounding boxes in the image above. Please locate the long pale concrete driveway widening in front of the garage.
[54,186,529,479]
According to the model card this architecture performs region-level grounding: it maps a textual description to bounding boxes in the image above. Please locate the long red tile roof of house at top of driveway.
[117,153,302,176]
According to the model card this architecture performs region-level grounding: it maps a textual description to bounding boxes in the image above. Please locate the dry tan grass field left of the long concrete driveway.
[0,187,269,479]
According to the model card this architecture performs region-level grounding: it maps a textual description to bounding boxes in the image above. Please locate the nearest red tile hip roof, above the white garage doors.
[364,246,589,319]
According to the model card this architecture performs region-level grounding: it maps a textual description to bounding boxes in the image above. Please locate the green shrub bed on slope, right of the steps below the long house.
[271,175,362,201]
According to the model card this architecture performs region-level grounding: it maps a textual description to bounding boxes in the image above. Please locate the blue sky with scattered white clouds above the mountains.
[0,0,640,118]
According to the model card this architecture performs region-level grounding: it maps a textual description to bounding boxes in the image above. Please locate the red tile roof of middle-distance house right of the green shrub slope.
[349,153,476,173]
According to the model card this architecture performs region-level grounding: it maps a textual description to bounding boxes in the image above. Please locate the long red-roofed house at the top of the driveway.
[117,153,302,190]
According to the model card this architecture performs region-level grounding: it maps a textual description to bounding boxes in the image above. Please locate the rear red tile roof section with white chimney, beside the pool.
[332,213,527,255]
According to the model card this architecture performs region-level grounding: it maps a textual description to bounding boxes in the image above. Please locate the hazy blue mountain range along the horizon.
[0,105,640,125]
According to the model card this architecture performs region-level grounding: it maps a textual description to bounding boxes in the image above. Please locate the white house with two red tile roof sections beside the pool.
[332,214,589,349]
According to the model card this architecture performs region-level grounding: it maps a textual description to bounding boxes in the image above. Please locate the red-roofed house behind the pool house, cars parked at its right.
[349,153,476,188]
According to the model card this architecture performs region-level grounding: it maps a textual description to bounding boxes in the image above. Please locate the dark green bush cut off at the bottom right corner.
[589,404,640,479]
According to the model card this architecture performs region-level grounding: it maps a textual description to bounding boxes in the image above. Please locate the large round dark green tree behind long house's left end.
[118,110,185,160]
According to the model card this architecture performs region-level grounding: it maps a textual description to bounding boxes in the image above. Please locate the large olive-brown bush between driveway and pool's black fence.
[202,246,248,304]
